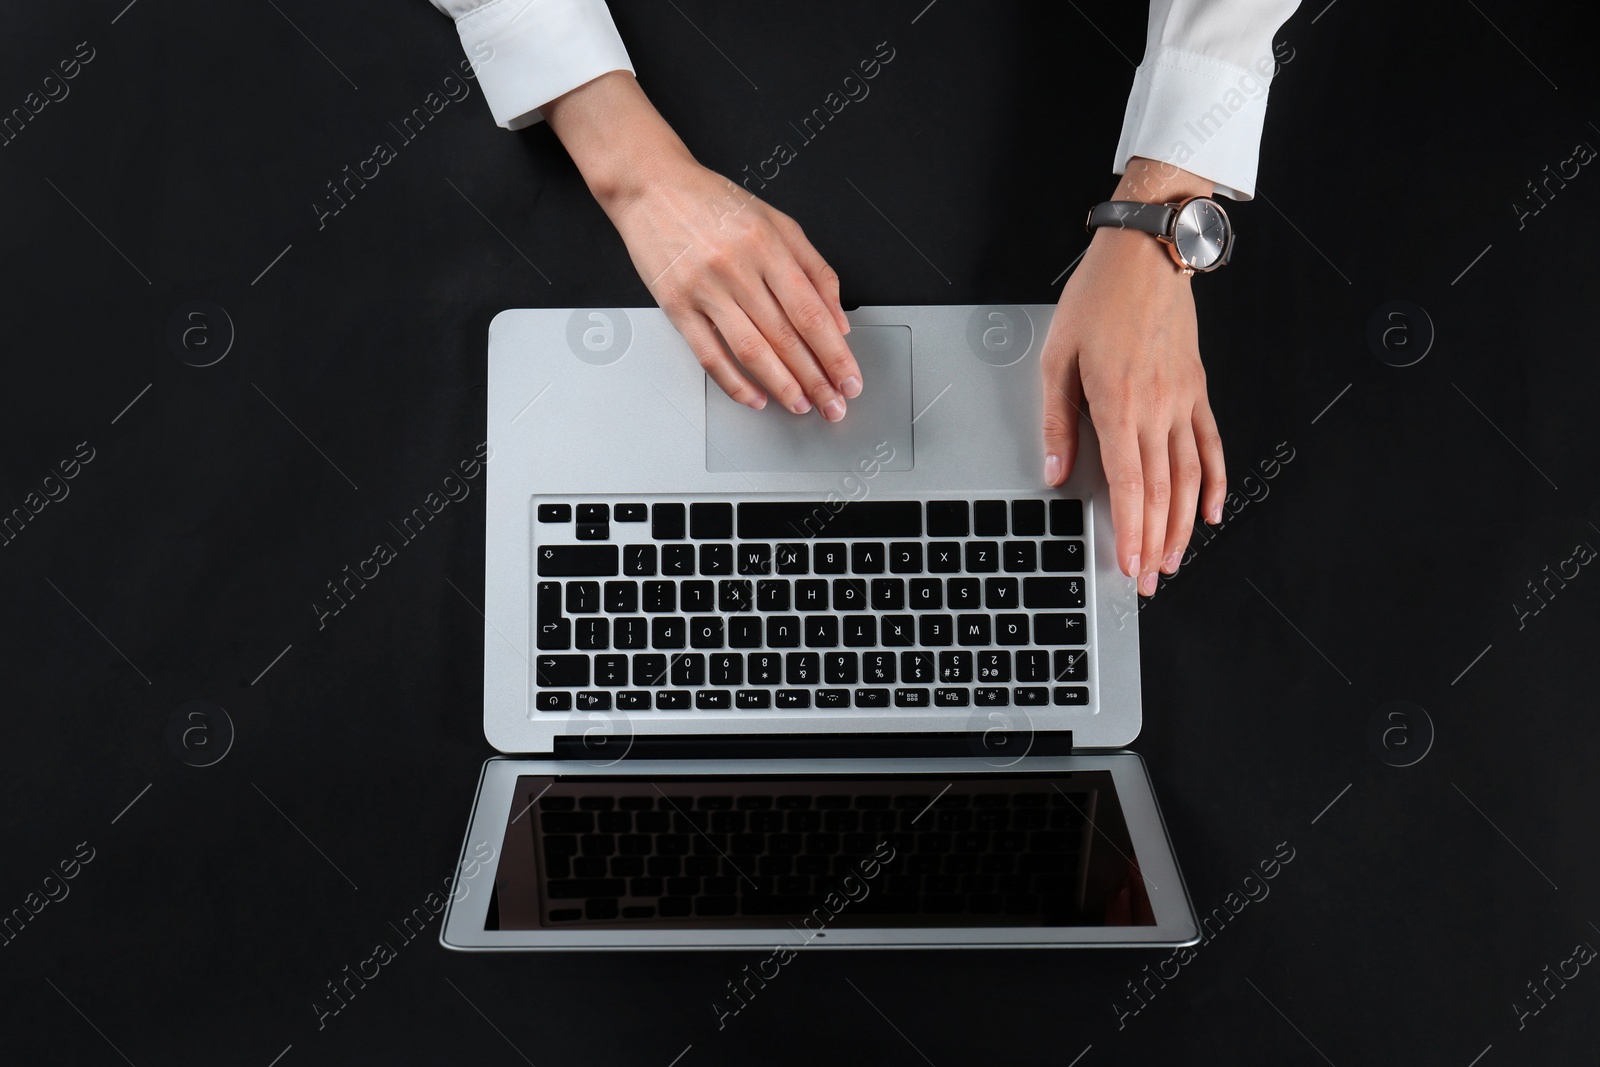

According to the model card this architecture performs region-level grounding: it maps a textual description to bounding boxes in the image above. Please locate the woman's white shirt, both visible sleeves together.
[434,0,1299,200]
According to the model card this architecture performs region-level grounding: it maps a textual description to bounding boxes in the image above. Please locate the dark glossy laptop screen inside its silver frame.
[485,769,1155,937]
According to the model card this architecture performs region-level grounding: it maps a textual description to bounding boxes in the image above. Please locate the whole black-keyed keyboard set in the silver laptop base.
[533,496,1090,713]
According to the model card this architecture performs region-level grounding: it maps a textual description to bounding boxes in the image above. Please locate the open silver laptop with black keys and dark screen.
[440,306,1198,963]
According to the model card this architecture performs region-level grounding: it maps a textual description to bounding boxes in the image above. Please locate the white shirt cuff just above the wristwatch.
[1112,48,1274,200]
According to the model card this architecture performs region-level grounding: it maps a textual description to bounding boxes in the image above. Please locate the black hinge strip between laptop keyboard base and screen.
[554,729,1072,763]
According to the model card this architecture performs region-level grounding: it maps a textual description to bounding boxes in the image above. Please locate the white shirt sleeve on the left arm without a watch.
[434,0,634,130]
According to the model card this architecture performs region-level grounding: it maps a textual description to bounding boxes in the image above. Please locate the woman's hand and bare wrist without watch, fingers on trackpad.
[544,70,862,422]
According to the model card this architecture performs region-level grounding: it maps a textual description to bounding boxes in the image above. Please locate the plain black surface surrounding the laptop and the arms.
[0,0,1600,1067]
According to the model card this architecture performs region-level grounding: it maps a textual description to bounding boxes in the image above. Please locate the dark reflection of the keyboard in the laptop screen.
[530,779,1096,926]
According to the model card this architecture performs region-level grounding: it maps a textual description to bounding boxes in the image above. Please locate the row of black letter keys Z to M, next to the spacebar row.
[538,539,1083,577]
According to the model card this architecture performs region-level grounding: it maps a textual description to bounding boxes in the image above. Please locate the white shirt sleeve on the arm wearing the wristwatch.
[1112,0,1299,200]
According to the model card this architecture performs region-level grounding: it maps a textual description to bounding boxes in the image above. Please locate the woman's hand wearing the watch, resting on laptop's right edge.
[1042,158,1227,595]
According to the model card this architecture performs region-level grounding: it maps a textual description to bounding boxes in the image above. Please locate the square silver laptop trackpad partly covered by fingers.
[706,326,914,474]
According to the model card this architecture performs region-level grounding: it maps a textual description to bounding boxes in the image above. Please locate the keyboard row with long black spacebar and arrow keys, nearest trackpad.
[538,498,1083,541]
